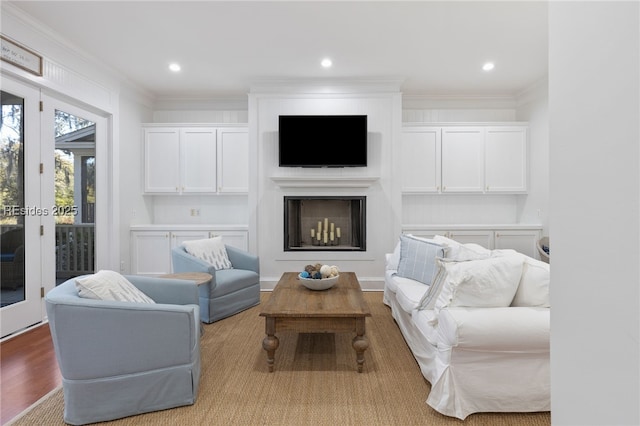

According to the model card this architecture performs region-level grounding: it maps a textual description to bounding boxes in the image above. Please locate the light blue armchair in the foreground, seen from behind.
[45,276,200,425]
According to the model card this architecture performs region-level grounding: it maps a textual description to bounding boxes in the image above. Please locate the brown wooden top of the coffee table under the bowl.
[260,272,371,318]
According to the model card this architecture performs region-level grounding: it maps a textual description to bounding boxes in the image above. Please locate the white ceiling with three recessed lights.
[9,1,548,98]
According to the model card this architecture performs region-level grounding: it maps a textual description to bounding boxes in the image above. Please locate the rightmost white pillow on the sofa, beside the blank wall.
[511,255,551,308]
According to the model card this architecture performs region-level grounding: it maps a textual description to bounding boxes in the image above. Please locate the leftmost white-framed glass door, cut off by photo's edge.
[0,77,42,337]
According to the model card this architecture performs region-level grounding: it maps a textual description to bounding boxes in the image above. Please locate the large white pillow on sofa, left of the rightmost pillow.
[434,256,523,312]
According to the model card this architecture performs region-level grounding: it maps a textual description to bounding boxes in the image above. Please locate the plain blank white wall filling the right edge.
[549,2,640,426]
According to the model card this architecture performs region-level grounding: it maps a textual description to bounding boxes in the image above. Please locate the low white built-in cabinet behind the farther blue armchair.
[131,225,249,276]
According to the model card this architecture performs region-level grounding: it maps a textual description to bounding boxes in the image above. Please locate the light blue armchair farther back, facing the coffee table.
[171,245,260,323]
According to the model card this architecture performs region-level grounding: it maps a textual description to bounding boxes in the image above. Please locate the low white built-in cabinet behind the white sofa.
[402,225,542,259]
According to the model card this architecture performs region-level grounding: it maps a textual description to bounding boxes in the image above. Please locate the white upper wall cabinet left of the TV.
[143,125,249,194]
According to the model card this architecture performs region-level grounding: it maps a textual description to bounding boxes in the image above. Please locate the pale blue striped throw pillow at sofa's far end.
[398,235,444,285]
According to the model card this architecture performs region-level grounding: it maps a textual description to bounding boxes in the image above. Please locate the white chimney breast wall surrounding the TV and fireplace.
[249,86,400,288]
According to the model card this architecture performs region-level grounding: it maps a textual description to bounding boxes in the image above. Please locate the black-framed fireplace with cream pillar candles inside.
[284,196,367,251]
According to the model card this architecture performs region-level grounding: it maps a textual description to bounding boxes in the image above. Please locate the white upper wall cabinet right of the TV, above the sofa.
[401,125,528,193]
